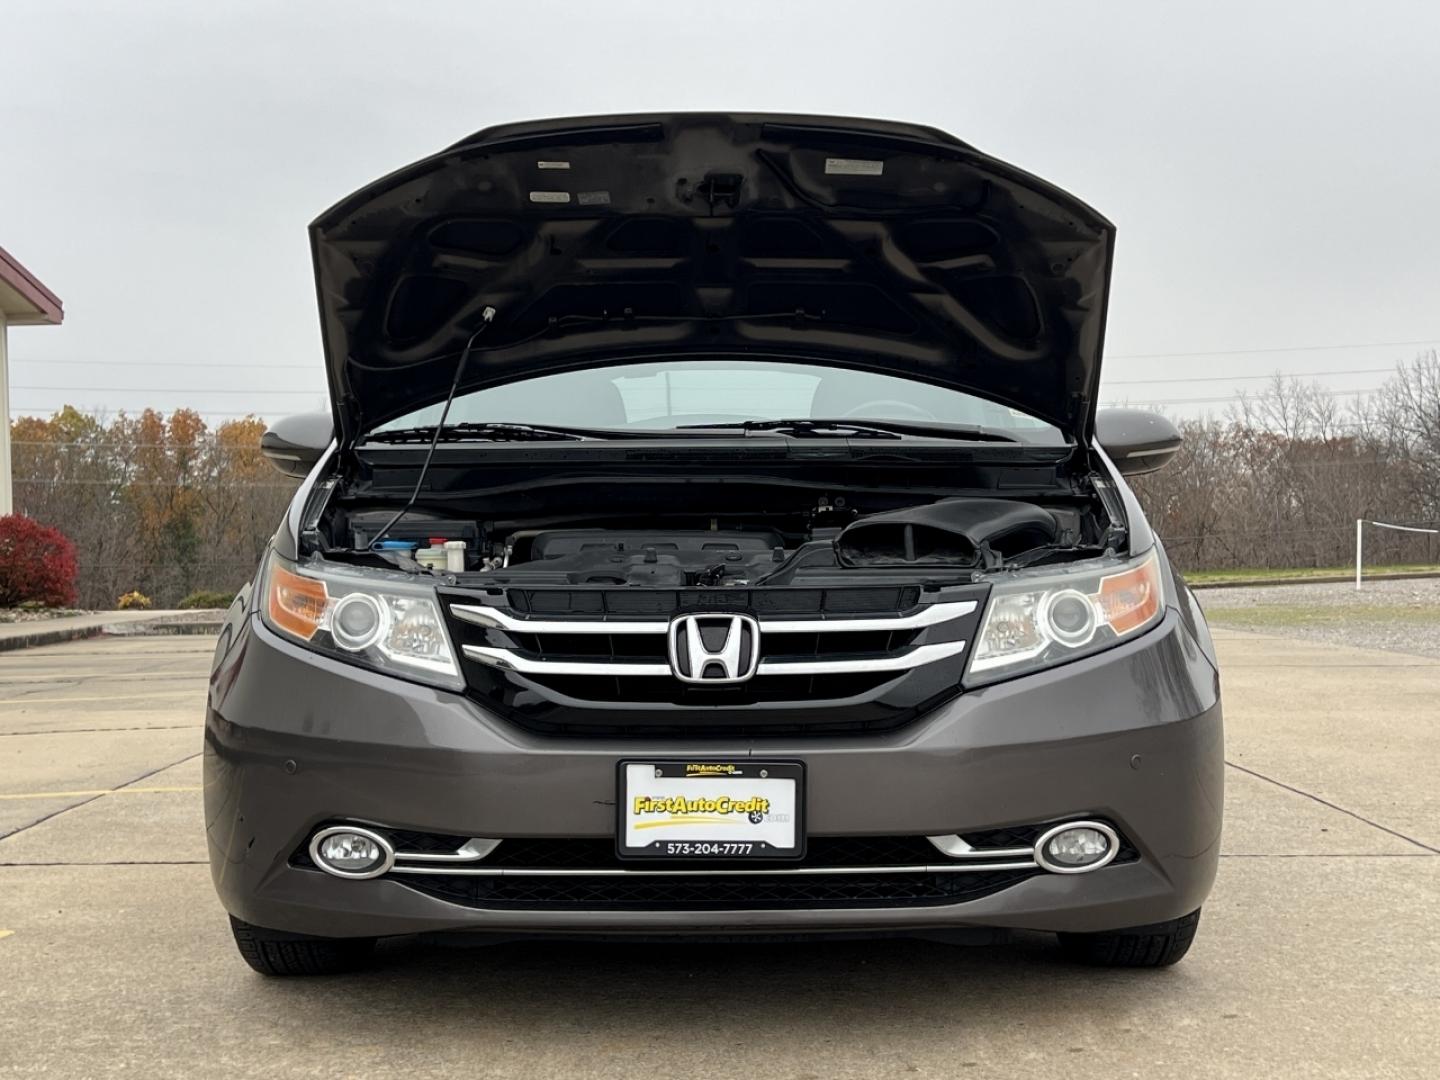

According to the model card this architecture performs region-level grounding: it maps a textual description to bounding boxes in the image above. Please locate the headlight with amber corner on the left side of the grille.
[264,552,465,688]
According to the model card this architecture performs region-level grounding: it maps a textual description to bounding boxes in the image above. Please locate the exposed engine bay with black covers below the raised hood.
[311,497,1123,589]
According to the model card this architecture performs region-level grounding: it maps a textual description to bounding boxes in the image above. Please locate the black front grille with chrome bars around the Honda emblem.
[441,585,989,739]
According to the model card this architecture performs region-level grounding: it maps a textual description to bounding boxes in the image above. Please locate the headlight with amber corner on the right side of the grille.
[966,550,1165,685]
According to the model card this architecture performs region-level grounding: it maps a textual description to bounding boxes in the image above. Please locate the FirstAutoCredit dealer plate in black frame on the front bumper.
[615,762,805,860]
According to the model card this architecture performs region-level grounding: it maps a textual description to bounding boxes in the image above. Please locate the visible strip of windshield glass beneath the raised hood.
[376,360,1066,446]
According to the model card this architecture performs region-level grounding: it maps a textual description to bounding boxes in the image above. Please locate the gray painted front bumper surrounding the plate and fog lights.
[204,612,1224,936]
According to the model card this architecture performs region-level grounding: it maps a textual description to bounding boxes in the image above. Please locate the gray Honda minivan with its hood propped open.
[204,114,1223,975]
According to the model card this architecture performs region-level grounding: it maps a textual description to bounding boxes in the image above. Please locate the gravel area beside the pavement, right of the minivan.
[1197,579,1440,658]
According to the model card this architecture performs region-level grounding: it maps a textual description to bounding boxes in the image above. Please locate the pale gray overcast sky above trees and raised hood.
[0,0,1440,418]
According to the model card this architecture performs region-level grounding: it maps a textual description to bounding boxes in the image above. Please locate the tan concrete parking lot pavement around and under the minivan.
[0,631,1440,1080]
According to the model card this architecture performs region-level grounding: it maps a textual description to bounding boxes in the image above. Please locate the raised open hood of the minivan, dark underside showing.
[311,114,1115,445]
